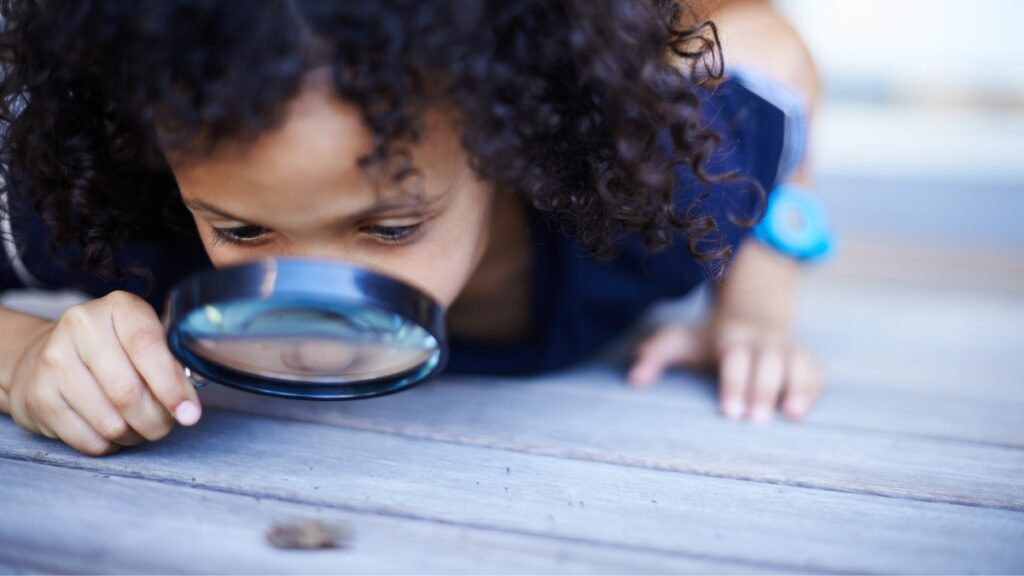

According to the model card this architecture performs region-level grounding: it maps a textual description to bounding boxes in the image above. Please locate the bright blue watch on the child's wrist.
[754,184,834,261]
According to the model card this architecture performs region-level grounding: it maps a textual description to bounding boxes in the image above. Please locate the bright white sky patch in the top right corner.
[776,0,1024,101]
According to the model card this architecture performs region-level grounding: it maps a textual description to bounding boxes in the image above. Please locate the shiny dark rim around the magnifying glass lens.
[166,257,447,400]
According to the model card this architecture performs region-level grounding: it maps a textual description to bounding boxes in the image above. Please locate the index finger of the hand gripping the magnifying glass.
[112,294,202,426]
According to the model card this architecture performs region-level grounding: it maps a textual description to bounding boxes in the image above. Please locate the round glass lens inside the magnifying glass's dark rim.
[182,300,438,383]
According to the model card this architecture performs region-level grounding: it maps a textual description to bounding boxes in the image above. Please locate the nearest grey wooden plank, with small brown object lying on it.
[0,459,761,574]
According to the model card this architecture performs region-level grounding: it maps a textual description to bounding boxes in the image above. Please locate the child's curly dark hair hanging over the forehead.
[0,0,745,286]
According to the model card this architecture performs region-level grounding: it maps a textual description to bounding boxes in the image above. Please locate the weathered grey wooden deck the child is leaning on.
[0,237,1024,573]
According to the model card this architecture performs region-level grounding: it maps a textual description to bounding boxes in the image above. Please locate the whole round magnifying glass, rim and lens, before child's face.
[166,258,447,400]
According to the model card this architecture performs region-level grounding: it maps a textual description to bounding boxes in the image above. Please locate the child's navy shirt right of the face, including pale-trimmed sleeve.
[449,76,803,374]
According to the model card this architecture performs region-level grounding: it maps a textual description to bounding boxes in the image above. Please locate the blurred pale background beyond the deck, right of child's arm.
[775,0,1024,291]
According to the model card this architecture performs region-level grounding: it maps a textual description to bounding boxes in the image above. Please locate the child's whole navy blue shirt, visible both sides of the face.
[0,75,802,374]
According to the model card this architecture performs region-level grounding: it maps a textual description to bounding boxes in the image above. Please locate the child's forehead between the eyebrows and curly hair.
[168,77,465,227]
